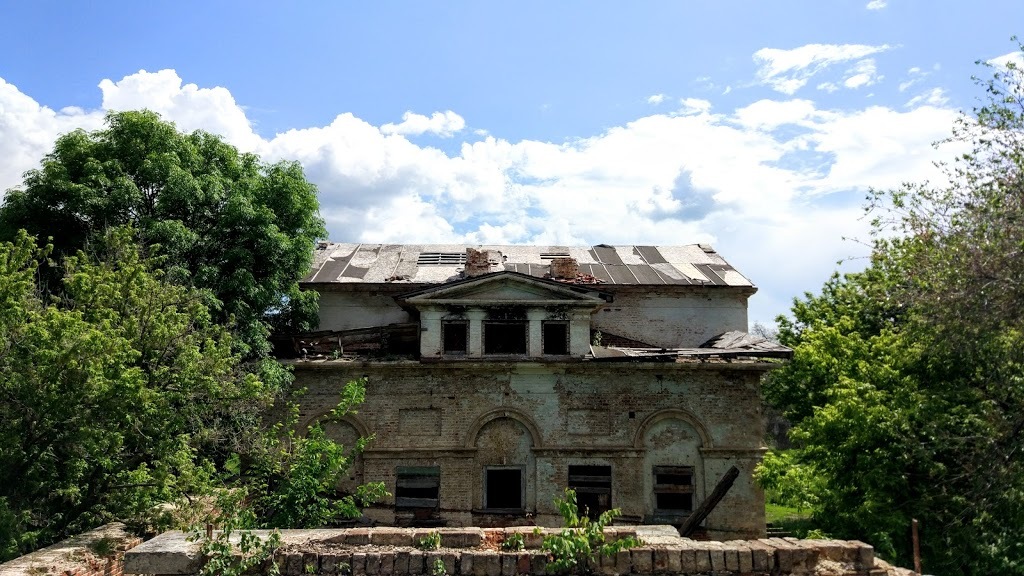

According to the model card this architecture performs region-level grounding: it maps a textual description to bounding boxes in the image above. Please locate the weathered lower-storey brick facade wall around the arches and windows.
[288,361,765,537]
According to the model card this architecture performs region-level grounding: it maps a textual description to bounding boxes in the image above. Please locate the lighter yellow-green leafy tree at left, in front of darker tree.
[0,230,272,556]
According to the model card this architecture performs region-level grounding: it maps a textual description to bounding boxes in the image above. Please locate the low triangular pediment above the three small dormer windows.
[401,272,605,306]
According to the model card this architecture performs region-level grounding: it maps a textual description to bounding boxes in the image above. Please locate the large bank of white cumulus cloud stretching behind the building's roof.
[0,68,955,321]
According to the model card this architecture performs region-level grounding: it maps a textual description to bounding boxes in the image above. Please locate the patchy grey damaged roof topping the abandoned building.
[303,242,753,287]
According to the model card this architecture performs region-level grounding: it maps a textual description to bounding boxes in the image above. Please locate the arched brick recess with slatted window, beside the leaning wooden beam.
[636,410,711,524]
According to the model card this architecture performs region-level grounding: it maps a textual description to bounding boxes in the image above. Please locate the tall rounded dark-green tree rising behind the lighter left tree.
[0,111,326,356]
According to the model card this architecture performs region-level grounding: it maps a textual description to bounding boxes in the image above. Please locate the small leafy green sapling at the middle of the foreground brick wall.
[541,488,640,574]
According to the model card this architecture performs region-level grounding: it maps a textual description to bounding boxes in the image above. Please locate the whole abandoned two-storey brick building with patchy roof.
[292,243,790,537]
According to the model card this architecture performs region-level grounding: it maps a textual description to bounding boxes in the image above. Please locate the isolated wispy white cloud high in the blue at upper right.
[754,44,890,94]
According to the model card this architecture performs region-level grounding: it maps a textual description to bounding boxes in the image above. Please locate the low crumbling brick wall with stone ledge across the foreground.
[125,526,886,576]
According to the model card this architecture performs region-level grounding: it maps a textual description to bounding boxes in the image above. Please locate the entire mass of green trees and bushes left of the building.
[0,112,384,561]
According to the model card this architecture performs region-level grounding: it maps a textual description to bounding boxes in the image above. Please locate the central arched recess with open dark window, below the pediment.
[469,410,540,516]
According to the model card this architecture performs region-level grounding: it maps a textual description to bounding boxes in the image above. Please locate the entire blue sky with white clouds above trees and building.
[0,0,1024,325]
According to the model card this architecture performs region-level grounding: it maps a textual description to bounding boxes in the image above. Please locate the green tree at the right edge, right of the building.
[762,42,1024,574]
